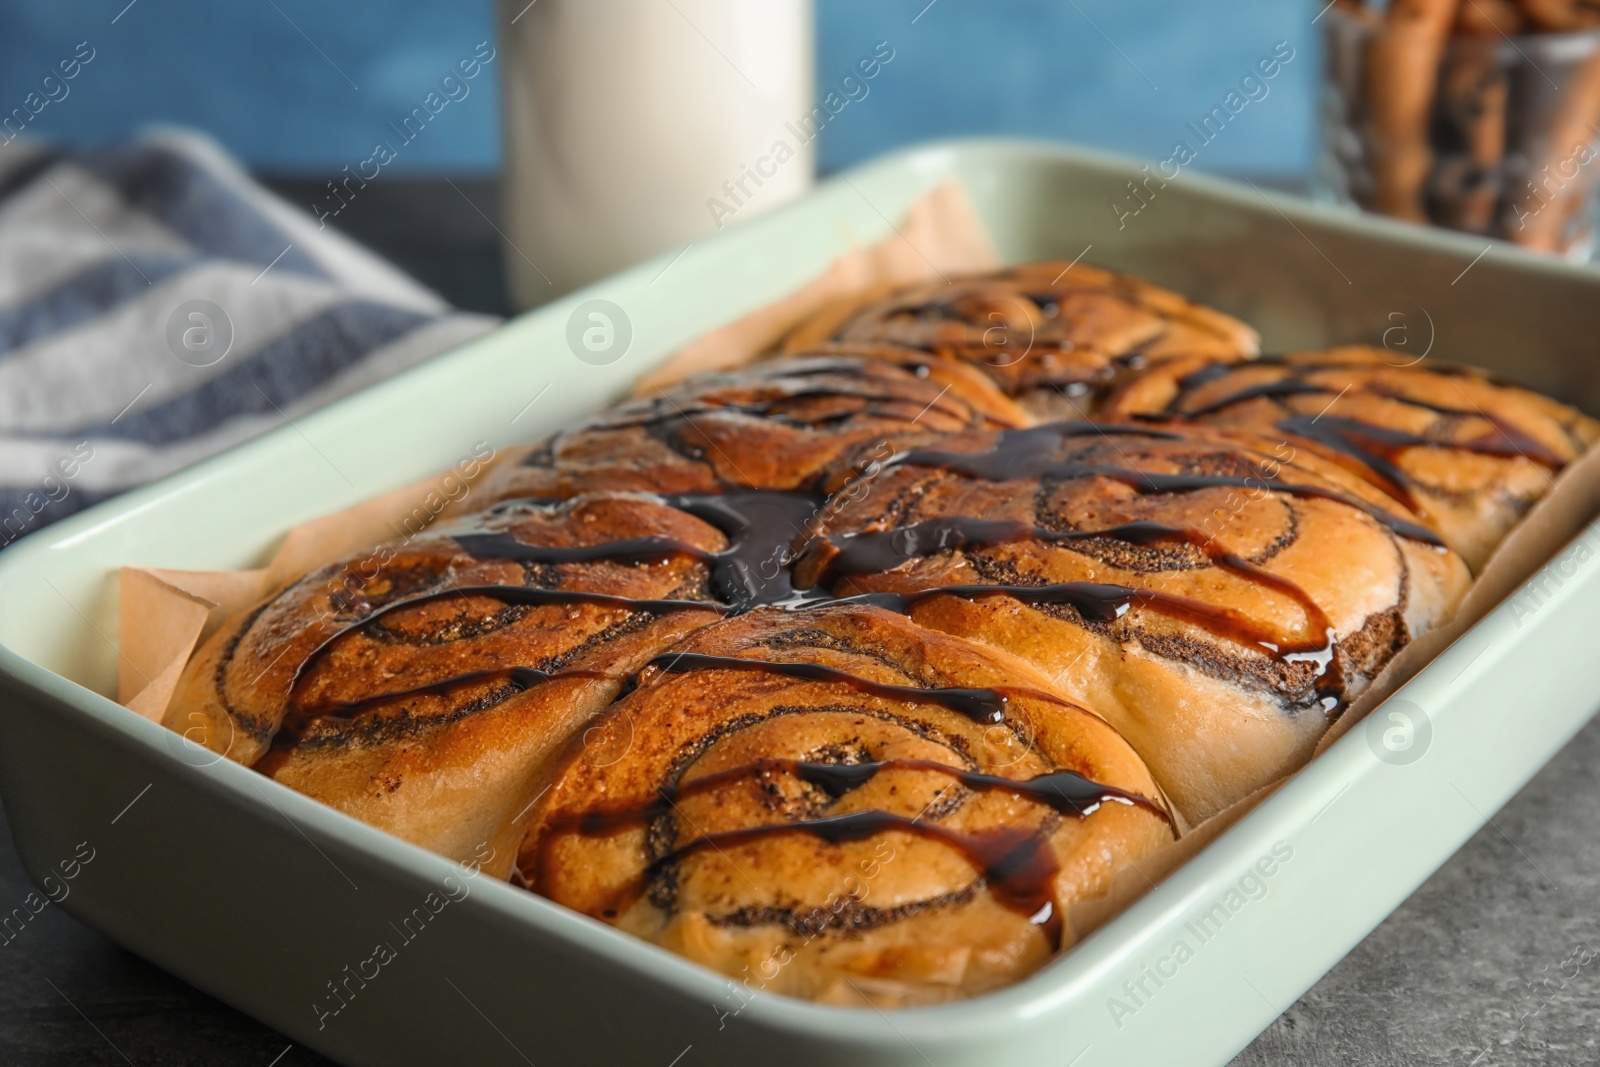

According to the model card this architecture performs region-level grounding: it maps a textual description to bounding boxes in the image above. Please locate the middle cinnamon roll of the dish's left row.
[462,346,1027,509]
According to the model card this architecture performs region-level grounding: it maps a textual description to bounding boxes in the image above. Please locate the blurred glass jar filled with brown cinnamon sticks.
[1317,3,1600,259]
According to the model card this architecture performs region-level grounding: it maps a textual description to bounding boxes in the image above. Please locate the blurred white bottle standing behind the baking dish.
[499,0,814,309]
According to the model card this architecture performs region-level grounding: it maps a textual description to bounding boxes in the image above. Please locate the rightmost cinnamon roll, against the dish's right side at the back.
[1106,346,1600,569]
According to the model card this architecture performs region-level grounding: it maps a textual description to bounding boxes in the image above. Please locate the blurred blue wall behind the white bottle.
[0,0,1322,178]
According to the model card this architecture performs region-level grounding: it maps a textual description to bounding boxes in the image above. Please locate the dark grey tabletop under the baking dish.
[0,179,1600,1067]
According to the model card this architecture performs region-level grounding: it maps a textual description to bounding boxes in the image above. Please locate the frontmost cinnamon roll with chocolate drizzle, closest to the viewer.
[518,606,1173,1006]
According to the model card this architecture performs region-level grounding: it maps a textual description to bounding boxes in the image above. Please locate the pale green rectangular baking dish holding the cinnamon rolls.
[0,141,1600,1067]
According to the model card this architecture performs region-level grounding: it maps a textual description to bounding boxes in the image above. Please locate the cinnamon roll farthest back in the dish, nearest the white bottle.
[784,261,1259,419]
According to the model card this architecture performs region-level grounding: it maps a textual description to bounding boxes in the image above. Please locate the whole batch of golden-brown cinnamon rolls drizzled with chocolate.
[152,254,1600,1006]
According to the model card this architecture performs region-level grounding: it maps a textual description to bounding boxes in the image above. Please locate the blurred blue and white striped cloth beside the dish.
[0,131,496,545]
